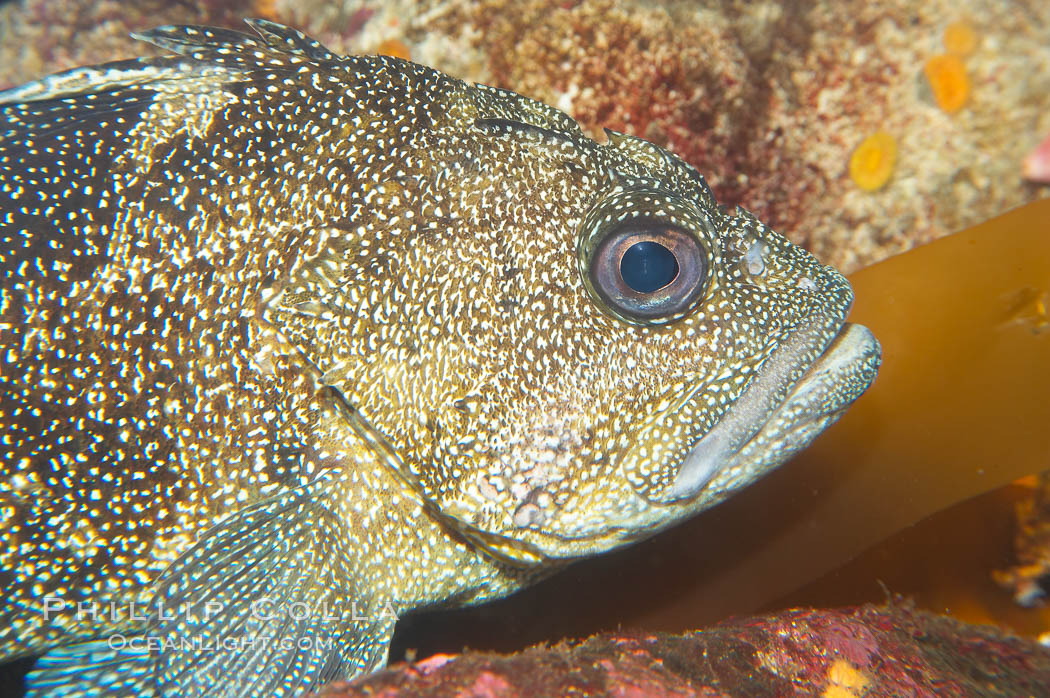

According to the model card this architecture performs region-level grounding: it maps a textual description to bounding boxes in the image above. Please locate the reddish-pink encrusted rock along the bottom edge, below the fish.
[319,606,1050,698]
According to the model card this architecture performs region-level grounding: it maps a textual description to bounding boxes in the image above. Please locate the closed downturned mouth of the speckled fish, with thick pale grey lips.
[659,318,881,507]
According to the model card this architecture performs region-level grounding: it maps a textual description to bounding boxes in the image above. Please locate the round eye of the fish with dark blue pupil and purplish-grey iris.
[589,219,708,322]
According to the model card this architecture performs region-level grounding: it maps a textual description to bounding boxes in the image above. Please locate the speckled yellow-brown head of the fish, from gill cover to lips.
[279,78,879,565]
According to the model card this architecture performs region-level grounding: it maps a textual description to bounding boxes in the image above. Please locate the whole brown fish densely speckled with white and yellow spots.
[0,20,879,696]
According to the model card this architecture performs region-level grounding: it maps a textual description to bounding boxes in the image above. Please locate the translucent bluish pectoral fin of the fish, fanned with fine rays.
[28,479,396,698]
